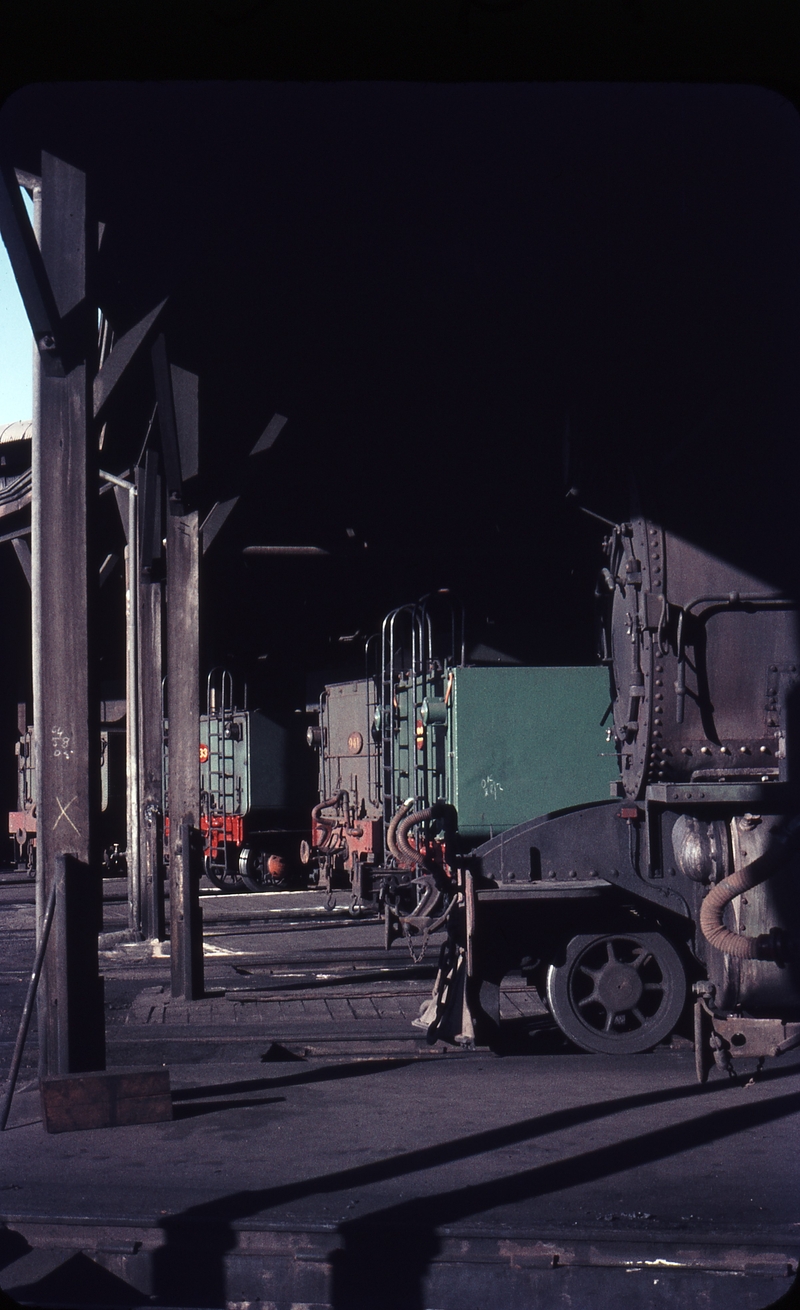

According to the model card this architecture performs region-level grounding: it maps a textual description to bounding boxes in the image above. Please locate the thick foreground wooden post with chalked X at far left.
[31,153,105,1074]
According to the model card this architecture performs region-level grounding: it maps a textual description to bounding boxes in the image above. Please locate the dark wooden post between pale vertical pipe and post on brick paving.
[136,451,165,942]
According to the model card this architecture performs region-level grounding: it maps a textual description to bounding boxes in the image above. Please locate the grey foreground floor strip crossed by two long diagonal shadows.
[1,1051,800,1241]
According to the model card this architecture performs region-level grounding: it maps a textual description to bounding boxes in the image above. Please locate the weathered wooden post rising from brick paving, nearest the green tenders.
[166,510,203,1001]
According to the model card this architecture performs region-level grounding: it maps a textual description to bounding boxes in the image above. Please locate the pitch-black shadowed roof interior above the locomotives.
[0,71,800,770]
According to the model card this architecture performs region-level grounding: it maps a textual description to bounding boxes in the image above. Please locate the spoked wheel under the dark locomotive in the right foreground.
[547,933,686,1055]
